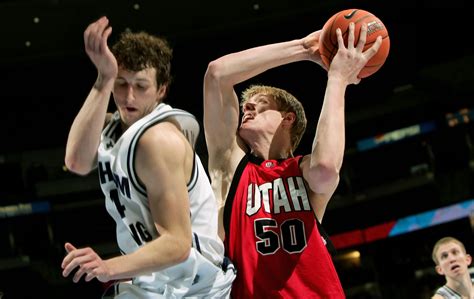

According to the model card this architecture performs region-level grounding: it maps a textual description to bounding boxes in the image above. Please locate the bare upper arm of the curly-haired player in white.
[135,128,191,237]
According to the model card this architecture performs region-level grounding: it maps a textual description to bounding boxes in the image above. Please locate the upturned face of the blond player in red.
[239,94,283,137]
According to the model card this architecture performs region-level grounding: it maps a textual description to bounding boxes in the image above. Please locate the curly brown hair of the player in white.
[111,30,173,92]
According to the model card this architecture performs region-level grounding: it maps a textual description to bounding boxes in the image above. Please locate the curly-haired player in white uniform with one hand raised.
[61,17,235,298]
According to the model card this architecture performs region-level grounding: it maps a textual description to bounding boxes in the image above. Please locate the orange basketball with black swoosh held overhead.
[319,9,390,78]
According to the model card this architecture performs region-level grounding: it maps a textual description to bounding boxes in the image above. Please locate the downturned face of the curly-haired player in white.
[114,68,163,127]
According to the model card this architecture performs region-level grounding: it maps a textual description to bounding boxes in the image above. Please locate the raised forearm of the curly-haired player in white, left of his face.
[65,79,113,175]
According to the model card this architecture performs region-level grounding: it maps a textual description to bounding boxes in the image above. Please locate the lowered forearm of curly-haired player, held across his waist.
[106,235,191,279]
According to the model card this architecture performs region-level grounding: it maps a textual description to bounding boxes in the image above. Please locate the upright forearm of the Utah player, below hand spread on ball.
[309,78,346,193]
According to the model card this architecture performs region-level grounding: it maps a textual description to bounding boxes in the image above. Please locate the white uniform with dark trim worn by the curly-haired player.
[98,104,235,298]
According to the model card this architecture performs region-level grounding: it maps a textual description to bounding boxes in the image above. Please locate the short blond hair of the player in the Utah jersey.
[240,85,307,153]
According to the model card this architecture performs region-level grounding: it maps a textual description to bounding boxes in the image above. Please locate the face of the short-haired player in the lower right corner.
[436,242,471,278]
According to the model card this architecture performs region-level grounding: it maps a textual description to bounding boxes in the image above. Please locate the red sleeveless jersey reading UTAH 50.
[224,155,345,299]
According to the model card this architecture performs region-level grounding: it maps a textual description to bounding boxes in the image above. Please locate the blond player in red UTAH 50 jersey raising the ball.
[204,23,381,299]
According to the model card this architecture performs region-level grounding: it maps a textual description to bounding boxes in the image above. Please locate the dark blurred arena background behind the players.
[0,0,474,299]
